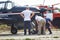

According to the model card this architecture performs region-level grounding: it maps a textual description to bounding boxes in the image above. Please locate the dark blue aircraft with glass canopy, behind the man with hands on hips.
[0,1,40,34]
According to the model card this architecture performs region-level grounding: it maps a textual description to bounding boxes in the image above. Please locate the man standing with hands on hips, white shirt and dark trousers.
[20,7,34,35]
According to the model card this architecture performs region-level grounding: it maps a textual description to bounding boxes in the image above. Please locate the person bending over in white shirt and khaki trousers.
[35,15,46,35]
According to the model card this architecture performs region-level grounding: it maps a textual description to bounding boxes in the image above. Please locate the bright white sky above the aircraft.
[0,0,60,8]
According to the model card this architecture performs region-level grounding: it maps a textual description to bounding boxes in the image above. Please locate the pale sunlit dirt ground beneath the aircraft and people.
[0,29,60,40]
